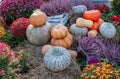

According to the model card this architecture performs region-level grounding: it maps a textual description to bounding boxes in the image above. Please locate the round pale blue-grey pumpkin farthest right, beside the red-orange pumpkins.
[99,22,116,38]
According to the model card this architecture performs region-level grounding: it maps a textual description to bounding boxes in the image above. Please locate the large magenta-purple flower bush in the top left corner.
[0,0,43,25]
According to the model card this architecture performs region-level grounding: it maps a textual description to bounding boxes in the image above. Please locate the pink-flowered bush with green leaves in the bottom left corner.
[0,43,29,79]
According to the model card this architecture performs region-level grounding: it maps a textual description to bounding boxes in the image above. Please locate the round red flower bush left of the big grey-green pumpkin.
[10,17,30,37]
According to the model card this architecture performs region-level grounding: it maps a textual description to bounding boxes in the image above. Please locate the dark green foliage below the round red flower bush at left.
[0,30,27,47]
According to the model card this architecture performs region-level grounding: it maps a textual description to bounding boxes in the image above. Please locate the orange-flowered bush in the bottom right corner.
[80,62,120,79]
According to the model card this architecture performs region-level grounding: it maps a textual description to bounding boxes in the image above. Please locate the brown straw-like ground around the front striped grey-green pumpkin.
[14,43,80,79]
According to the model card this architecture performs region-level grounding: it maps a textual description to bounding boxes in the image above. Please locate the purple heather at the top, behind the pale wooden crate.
[41,0,72,16]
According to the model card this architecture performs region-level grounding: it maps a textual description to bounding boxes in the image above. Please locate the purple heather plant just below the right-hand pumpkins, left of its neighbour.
[77,37,106,57]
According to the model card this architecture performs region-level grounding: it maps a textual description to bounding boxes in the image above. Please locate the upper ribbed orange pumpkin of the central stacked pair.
[51,24,68,38]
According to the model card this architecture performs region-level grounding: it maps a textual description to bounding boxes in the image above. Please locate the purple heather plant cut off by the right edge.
[104,41,120,66]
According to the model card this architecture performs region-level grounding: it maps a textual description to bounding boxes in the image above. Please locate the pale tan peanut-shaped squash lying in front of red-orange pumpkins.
[76,18,93,27]
